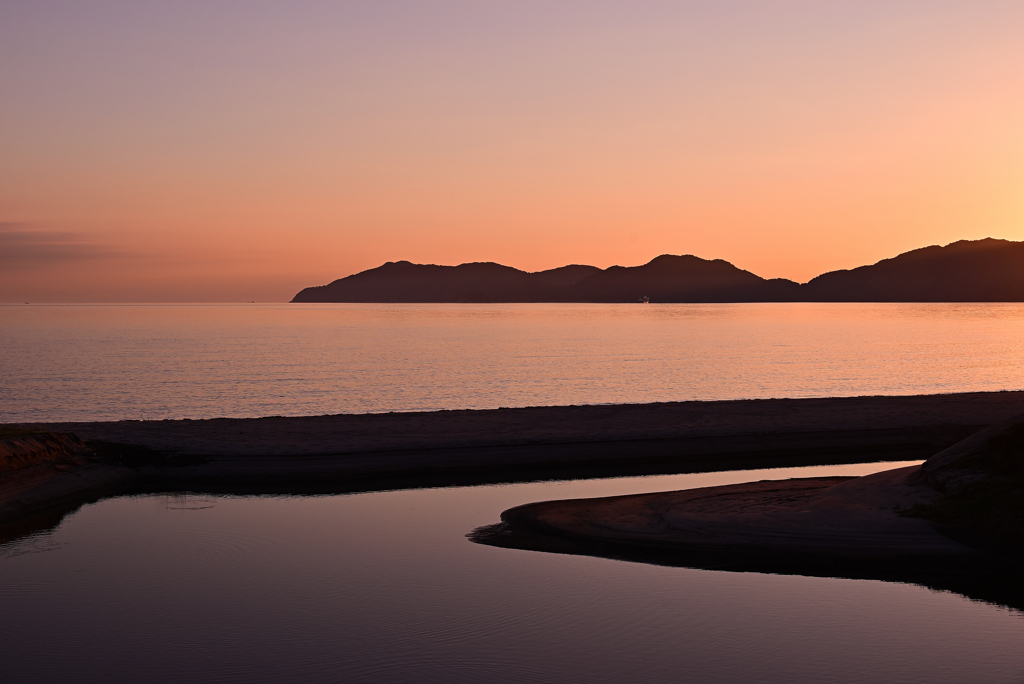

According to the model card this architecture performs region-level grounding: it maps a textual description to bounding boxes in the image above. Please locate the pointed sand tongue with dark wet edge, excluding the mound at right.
[468,466,1024,610]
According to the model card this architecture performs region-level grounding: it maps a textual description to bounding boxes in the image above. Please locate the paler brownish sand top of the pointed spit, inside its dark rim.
[483,466,973,559]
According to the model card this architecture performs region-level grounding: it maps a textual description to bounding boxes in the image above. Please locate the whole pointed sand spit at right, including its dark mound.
[470,416,1024,609]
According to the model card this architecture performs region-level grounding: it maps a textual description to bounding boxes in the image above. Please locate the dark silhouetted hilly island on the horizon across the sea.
[292,238,1024,303]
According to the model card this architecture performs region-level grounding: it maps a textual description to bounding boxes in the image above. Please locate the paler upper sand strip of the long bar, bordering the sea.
[22,391,1024,457]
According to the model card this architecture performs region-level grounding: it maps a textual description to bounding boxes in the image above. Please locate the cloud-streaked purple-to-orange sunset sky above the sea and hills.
[0,0,1024,302]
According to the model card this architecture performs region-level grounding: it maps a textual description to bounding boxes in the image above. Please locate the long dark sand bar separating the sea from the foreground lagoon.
[0,392,1024,544]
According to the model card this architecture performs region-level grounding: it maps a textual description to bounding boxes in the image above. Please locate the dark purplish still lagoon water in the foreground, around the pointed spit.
[0,464,1024,684]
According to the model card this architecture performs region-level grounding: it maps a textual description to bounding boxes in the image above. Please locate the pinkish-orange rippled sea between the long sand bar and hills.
[0,304,1024,422]
